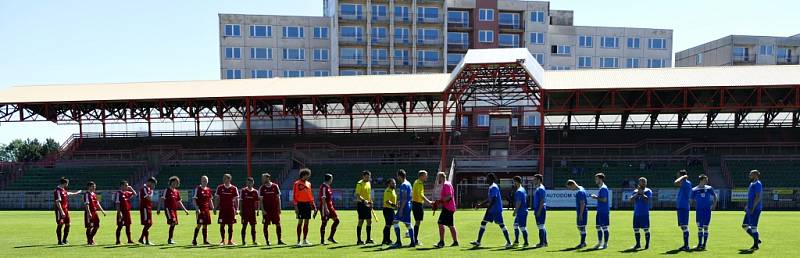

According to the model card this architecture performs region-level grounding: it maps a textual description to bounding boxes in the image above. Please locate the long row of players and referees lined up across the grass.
[48,169,762,251]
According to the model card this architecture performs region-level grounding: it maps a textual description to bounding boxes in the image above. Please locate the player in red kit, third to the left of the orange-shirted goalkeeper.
[214,174,239,245]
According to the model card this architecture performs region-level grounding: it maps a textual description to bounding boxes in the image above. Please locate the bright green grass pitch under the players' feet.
[0,210,800,258]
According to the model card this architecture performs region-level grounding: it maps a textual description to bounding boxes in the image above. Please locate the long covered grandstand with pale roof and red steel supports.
[0,46,800,212]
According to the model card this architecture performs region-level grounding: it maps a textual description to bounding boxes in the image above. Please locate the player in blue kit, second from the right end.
[692,175,717,250]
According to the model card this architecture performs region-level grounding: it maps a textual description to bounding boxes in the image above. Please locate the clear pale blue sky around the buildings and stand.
[0,0,800,143]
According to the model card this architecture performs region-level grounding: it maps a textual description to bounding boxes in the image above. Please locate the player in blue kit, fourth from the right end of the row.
[629,177,653,250]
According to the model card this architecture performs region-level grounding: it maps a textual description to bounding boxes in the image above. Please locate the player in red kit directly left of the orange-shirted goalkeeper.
[258,173,285,245]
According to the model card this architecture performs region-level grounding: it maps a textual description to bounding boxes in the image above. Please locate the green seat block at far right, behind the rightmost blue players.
[725,159,800,188]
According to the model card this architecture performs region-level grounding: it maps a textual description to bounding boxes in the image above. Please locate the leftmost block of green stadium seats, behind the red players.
[4,166,142,191]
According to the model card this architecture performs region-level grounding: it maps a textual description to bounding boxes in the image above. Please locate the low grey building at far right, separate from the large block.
[675,34,800,67]
